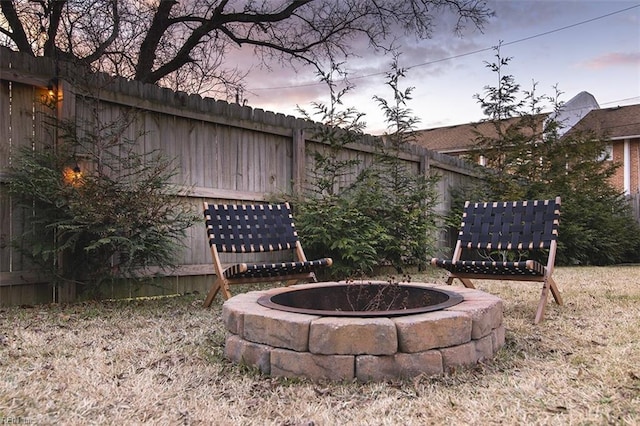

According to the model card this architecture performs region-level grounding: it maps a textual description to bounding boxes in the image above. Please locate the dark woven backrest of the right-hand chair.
[458,197,560,250]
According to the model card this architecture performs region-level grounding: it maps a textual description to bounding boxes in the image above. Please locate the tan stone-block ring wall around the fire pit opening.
[222,283,505,382]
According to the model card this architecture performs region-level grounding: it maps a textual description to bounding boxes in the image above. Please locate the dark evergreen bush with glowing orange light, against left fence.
[10,104,195,297]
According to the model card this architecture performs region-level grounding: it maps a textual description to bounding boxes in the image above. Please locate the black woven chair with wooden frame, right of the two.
[431,197,562,324]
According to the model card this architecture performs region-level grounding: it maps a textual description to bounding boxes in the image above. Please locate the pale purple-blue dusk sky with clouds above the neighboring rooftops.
[232,0,640,134]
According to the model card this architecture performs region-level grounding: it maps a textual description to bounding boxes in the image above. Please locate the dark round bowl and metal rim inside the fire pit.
[258,282,463,317]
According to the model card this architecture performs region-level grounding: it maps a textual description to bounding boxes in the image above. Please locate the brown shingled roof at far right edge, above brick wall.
[571,104,640,139]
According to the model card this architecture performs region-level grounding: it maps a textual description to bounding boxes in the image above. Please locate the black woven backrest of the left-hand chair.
[204,203,298,253]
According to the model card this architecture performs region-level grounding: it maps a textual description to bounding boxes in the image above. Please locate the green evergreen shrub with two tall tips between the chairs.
[292,64,437,278]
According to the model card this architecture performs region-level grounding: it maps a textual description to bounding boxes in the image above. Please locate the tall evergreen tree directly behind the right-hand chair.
[475,46,640,265]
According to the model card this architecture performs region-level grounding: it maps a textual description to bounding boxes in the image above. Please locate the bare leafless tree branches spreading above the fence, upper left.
[0,0,492,96]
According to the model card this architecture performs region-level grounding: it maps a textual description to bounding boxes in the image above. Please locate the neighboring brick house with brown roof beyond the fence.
[414,92,640,195]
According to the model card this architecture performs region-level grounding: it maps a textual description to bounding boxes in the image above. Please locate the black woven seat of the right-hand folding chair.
[432,259,545,276]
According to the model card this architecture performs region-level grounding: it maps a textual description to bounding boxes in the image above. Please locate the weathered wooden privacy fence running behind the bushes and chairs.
[0,48,478,306]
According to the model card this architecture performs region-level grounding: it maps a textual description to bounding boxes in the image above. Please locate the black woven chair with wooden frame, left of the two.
[204,202,333,306]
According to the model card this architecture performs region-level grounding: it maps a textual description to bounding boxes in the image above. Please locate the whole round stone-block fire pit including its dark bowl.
[222,282,505,382]
